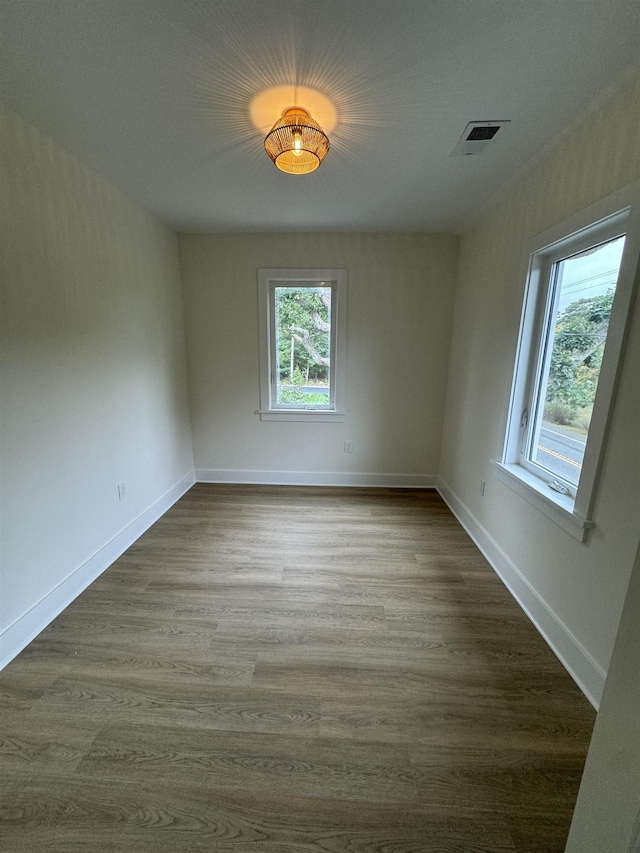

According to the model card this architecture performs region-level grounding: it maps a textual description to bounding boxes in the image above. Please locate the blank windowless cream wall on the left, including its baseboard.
[0,106,193,659]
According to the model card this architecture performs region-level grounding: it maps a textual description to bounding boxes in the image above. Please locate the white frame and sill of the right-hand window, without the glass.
[494,181,640,542]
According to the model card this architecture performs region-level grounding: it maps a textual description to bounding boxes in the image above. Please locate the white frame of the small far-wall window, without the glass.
[258,269,347,423]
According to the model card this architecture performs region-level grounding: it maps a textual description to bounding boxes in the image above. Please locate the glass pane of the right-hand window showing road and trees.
[530,236,624,486]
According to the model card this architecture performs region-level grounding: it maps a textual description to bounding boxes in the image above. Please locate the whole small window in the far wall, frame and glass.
[258,269,347,421]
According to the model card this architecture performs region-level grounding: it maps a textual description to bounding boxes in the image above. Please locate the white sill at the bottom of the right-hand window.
[493,459,594,542]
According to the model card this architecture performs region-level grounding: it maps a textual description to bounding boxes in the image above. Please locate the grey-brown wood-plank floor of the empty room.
[0,485,594,853]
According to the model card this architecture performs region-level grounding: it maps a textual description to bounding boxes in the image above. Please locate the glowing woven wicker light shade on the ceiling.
[264,107,329,175]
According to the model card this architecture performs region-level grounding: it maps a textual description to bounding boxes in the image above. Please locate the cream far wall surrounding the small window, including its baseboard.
[179,234,458,484]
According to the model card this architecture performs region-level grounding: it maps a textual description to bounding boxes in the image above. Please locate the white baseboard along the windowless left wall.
[0,471,196,669]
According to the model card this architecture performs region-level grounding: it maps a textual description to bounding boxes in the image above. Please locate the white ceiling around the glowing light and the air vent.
[0,0,640,231]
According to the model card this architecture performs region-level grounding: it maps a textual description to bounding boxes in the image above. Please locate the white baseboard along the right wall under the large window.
[437,479,606,711]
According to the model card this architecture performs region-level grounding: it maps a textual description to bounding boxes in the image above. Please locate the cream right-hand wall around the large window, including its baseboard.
[440,73,640,701]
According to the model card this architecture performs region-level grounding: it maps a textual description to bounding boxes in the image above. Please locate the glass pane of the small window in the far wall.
[274,287,331,407]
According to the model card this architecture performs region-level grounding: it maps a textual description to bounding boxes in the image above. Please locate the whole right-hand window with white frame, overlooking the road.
[496,191,637,541]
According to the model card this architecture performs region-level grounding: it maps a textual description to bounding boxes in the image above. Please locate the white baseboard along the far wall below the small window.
[196,468,437,489]
